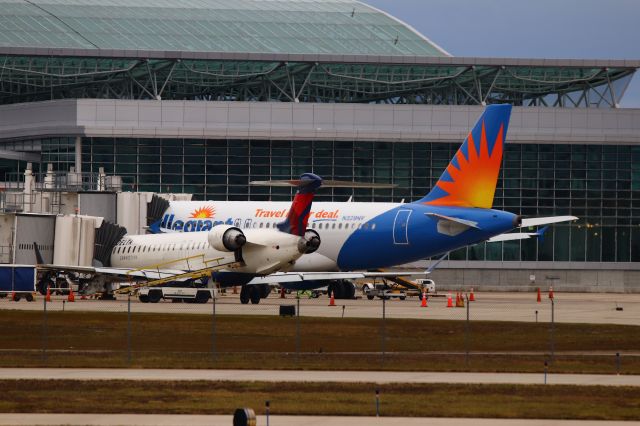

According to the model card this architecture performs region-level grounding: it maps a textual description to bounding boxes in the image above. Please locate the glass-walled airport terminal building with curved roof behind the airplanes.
[0,0,640,291]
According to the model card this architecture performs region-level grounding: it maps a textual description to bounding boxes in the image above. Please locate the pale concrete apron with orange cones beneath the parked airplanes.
[0,292,640,325]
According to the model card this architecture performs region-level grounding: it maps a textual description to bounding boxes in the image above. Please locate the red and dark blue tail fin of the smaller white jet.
[278,173,322,237]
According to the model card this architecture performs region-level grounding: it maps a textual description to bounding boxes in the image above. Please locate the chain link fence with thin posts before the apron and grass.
[0,289,640,374]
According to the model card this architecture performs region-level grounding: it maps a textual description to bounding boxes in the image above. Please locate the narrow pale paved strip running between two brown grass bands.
[0,368,640,386]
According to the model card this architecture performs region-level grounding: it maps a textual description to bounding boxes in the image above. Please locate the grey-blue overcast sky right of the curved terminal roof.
[361,0,640,108]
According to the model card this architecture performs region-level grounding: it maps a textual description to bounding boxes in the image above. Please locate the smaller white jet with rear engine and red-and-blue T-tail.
[34,173,330,303]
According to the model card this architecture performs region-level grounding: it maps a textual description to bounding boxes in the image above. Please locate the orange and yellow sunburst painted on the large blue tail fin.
[425,121,504,209]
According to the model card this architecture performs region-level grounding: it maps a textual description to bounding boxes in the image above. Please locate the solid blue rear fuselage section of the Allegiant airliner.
[338,203,516,271]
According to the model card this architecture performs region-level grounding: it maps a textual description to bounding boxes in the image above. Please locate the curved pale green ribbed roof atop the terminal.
[0,0,448,56]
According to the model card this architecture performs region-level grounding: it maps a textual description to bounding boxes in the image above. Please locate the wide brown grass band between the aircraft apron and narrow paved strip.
[0,311,640,374]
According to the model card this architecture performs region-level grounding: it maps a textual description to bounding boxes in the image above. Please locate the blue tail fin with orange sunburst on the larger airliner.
[417,104,511,209]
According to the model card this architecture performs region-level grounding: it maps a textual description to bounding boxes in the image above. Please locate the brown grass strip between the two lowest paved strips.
[0,380,640,420]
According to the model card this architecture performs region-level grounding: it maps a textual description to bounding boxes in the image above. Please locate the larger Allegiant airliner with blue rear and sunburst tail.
[149,104,577,297]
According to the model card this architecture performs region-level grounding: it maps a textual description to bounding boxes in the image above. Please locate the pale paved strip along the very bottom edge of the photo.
[0,413,640,426]
